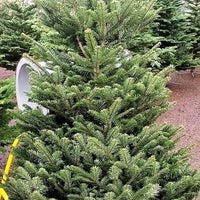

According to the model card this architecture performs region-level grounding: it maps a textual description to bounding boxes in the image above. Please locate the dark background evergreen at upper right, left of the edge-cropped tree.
[154,0,198,70]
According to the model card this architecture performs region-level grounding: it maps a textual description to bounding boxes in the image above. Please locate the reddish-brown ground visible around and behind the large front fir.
[0,68,200,169]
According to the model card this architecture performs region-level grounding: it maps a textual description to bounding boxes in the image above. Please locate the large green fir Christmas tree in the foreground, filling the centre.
[4,0,200,200]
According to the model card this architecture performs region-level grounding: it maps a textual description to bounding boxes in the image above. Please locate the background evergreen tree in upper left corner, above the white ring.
[0,1,39,69]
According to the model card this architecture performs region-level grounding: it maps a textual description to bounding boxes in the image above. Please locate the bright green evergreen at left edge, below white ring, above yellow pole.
[0,78,19,150]
